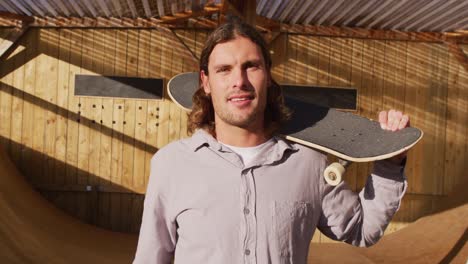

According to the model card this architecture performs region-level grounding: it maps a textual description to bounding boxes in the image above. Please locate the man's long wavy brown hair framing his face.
[188,17,290,135]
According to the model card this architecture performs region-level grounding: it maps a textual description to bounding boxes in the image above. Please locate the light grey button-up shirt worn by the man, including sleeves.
[134,130,406,264]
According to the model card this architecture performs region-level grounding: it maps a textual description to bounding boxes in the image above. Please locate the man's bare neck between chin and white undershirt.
[215,124,269,147]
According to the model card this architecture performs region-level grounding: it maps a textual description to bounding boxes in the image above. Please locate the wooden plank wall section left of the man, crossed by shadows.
[0,29,206,232]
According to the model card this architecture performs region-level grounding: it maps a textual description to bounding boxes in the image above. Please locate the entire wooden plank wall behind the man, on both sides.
[0,29,468,238]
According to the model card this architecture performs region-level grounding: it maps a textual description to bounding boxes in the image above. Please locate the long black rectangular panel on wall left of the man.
[75,74,164,99]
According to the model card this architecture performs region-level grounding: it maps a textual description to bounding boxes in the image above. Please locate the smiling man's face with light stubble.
[201,37,269,129]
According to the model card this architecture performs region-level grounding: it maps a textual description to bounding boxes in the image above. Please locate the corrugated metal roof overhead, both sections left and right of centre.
[0,0,468,32]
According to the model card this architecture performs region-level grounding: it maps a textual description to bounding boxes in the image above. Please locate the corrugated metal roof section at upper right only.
[257,0,468,32]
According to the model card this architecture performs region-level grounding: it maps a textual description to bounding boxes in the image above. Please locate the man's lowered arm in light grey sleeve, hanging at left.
[133,155,176,264]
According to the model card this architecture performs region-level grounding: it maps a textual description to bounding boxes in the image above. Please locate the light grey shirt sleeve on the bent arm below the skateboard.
[318,161,407,246]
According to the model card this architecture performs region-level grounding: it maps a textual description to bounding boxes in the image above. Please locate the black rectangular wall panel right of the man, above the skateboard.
[281,85,357,110]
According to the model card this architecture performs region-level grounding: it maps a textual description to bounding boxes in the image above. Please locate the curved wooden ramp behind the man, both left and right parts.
[0,145,468,264]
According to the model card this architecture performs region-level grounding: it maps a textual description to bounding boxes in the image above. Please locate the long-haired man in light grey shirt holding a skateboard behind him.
[134,17,408,264]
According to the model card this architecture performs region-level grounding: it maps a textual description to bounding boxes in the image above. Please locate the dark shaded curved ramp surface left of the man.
[0,148,137,264]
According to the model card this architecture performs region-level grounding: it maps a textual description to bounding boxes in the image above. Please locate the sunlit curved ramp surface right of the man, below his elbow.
[309,181,468,264]
